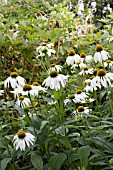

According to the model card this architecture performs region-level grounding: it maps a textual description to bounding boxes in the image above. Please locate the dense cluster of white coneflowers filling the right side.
[64,45,113,116]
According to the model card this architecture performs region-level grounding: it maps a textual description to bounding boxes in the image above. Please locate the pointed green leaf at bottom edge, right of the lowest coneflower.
[31,152,43,170]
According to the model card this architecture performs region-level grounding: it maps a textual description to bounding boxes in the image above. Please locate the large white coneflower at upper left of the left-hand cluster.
[4,72,25,89]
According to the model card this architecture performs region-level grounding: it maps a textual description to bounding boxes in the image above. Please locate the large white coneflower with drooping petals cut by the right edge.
[91,69,113,89]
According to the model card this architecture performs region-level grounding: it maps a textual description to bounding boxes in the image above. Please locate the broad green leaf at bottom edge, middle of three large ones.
[49,153,67,170]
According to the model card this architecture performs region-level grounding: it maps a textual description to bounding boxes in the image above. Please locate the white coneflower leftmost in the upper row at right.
[66,50,81,65]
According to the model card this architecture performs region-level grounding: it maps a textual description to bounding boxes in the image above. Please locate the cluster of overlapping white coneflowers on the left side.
[1,72,46,108]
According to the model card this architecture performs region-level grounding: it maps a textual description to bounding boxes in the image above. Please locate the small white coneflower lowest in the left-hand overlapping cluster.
[16,96,31,108]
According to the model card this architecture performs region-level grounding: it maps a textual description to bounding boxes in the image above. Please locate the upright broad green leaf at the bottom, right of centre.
[78,146,91,170]
